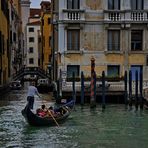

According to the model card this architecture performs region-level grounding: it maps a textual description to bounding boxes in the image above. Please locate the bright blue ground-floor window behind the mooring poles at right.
[130,65,143,81]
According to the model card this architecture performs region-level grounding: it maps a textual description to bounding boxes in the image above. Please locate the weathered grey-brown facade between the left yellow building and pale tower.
[9,0,23,78]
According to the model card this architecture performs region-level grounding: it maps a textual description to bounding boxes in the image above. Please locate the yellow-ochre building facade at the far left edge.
[0,0,10,86]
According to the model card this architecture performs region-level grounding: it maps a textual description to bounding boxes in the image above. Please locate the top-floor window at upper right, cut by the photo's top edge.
[131,0,144,10]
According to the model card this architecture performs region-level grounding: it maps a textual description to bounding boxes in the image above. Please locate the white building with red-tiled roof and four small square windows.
[26,8,41,67]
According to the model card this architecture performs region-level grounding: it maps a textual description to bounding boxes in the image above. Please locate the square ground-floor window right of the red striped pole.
[107,65,120,77]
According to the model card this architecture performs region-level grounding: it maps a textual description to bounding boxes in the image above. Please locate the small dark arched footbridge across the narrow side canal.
[12,67,50,80]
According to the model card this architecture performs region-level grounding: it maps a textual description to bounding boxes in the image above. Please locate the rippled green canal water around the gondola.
[0,84,148,148]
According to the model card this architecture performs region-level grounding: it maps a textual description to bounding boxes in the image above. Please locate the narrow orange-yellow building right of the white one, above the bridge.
[40,1,52,77]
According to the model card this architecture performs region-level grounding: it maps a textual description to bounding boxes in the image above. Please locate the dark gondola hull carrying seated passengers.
[22,101,74,126]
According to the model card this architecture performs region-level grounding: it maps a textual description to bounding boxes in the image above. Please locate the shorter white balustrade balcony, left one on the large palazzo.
[61,9,85,23]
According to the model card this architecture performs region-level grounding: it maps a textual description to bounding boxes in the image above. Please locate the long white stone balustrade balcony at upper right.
[104,10,148,23]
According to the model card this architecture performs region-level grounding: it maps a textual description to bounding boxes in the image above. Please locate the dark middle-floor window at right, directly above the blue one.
[131,30,143,51]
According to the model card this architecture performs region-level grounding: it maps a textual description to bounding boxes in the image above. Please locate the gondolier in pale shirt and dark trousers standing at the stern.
[27,82,40,109]
